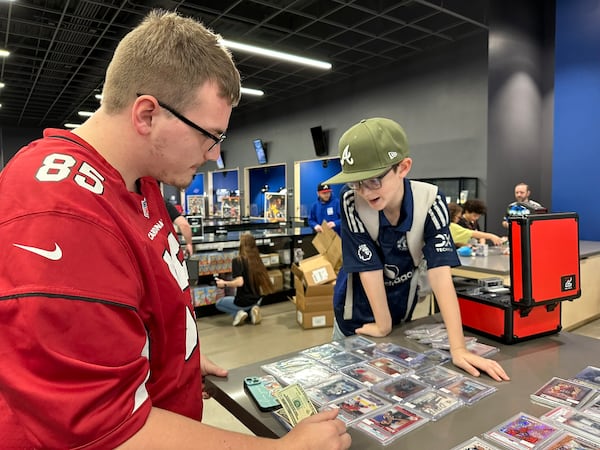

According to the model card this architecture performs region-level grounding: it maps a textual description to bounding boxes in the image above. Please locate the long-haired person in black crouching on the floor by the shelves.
[215,233,273,327]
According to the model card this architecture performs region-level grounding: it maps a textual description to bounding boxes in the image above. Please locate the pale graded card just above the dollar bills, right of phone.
[261,356,335,388]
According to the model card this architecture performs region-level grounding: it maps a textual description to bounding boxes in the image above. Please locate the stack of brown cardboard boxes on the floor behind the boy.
[292,224,342,329]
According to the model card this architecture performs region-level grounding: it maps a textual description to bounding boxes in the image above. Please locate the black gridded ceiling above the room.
[0,0,488,128]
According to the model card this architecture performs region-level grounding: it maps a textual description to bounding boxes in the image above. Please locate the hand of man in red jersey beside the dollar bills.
[281,409,352,450]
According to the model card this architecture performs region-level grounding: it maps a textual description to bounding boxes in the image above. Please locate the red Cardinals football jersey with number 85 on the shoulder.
[0,130,202,448]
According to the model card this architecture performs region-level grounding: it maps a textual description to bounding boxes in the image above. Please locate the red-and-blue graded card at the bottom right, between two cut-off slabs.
[484,412,560,450]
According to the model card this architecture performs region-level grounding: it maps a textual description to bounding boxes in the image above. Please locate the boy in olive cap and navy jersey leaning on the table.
[325,117,509,381]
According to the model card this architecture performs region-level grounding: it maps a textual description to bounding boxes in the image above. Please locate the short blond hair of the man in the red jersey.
[102,10,240,114]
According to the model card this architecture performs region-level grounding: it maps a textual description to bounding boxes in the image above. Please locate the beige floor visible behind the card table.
[198,302,600,433]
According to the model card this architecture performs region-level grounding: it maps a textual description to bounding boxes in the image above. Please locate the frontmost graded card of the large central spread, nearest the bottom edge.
[352,405,429,445]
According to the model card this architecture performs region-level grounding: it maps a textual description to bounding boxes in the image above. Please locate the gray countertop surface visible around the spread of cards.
[206,316,599,450]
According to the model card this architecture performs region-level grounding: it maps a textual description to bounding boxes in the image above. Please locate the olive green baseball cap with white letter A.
[325,117,409,184]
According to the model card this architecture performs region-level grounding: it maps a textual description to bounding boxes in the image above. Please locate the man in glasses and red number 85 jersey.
[0,10,351,450]
